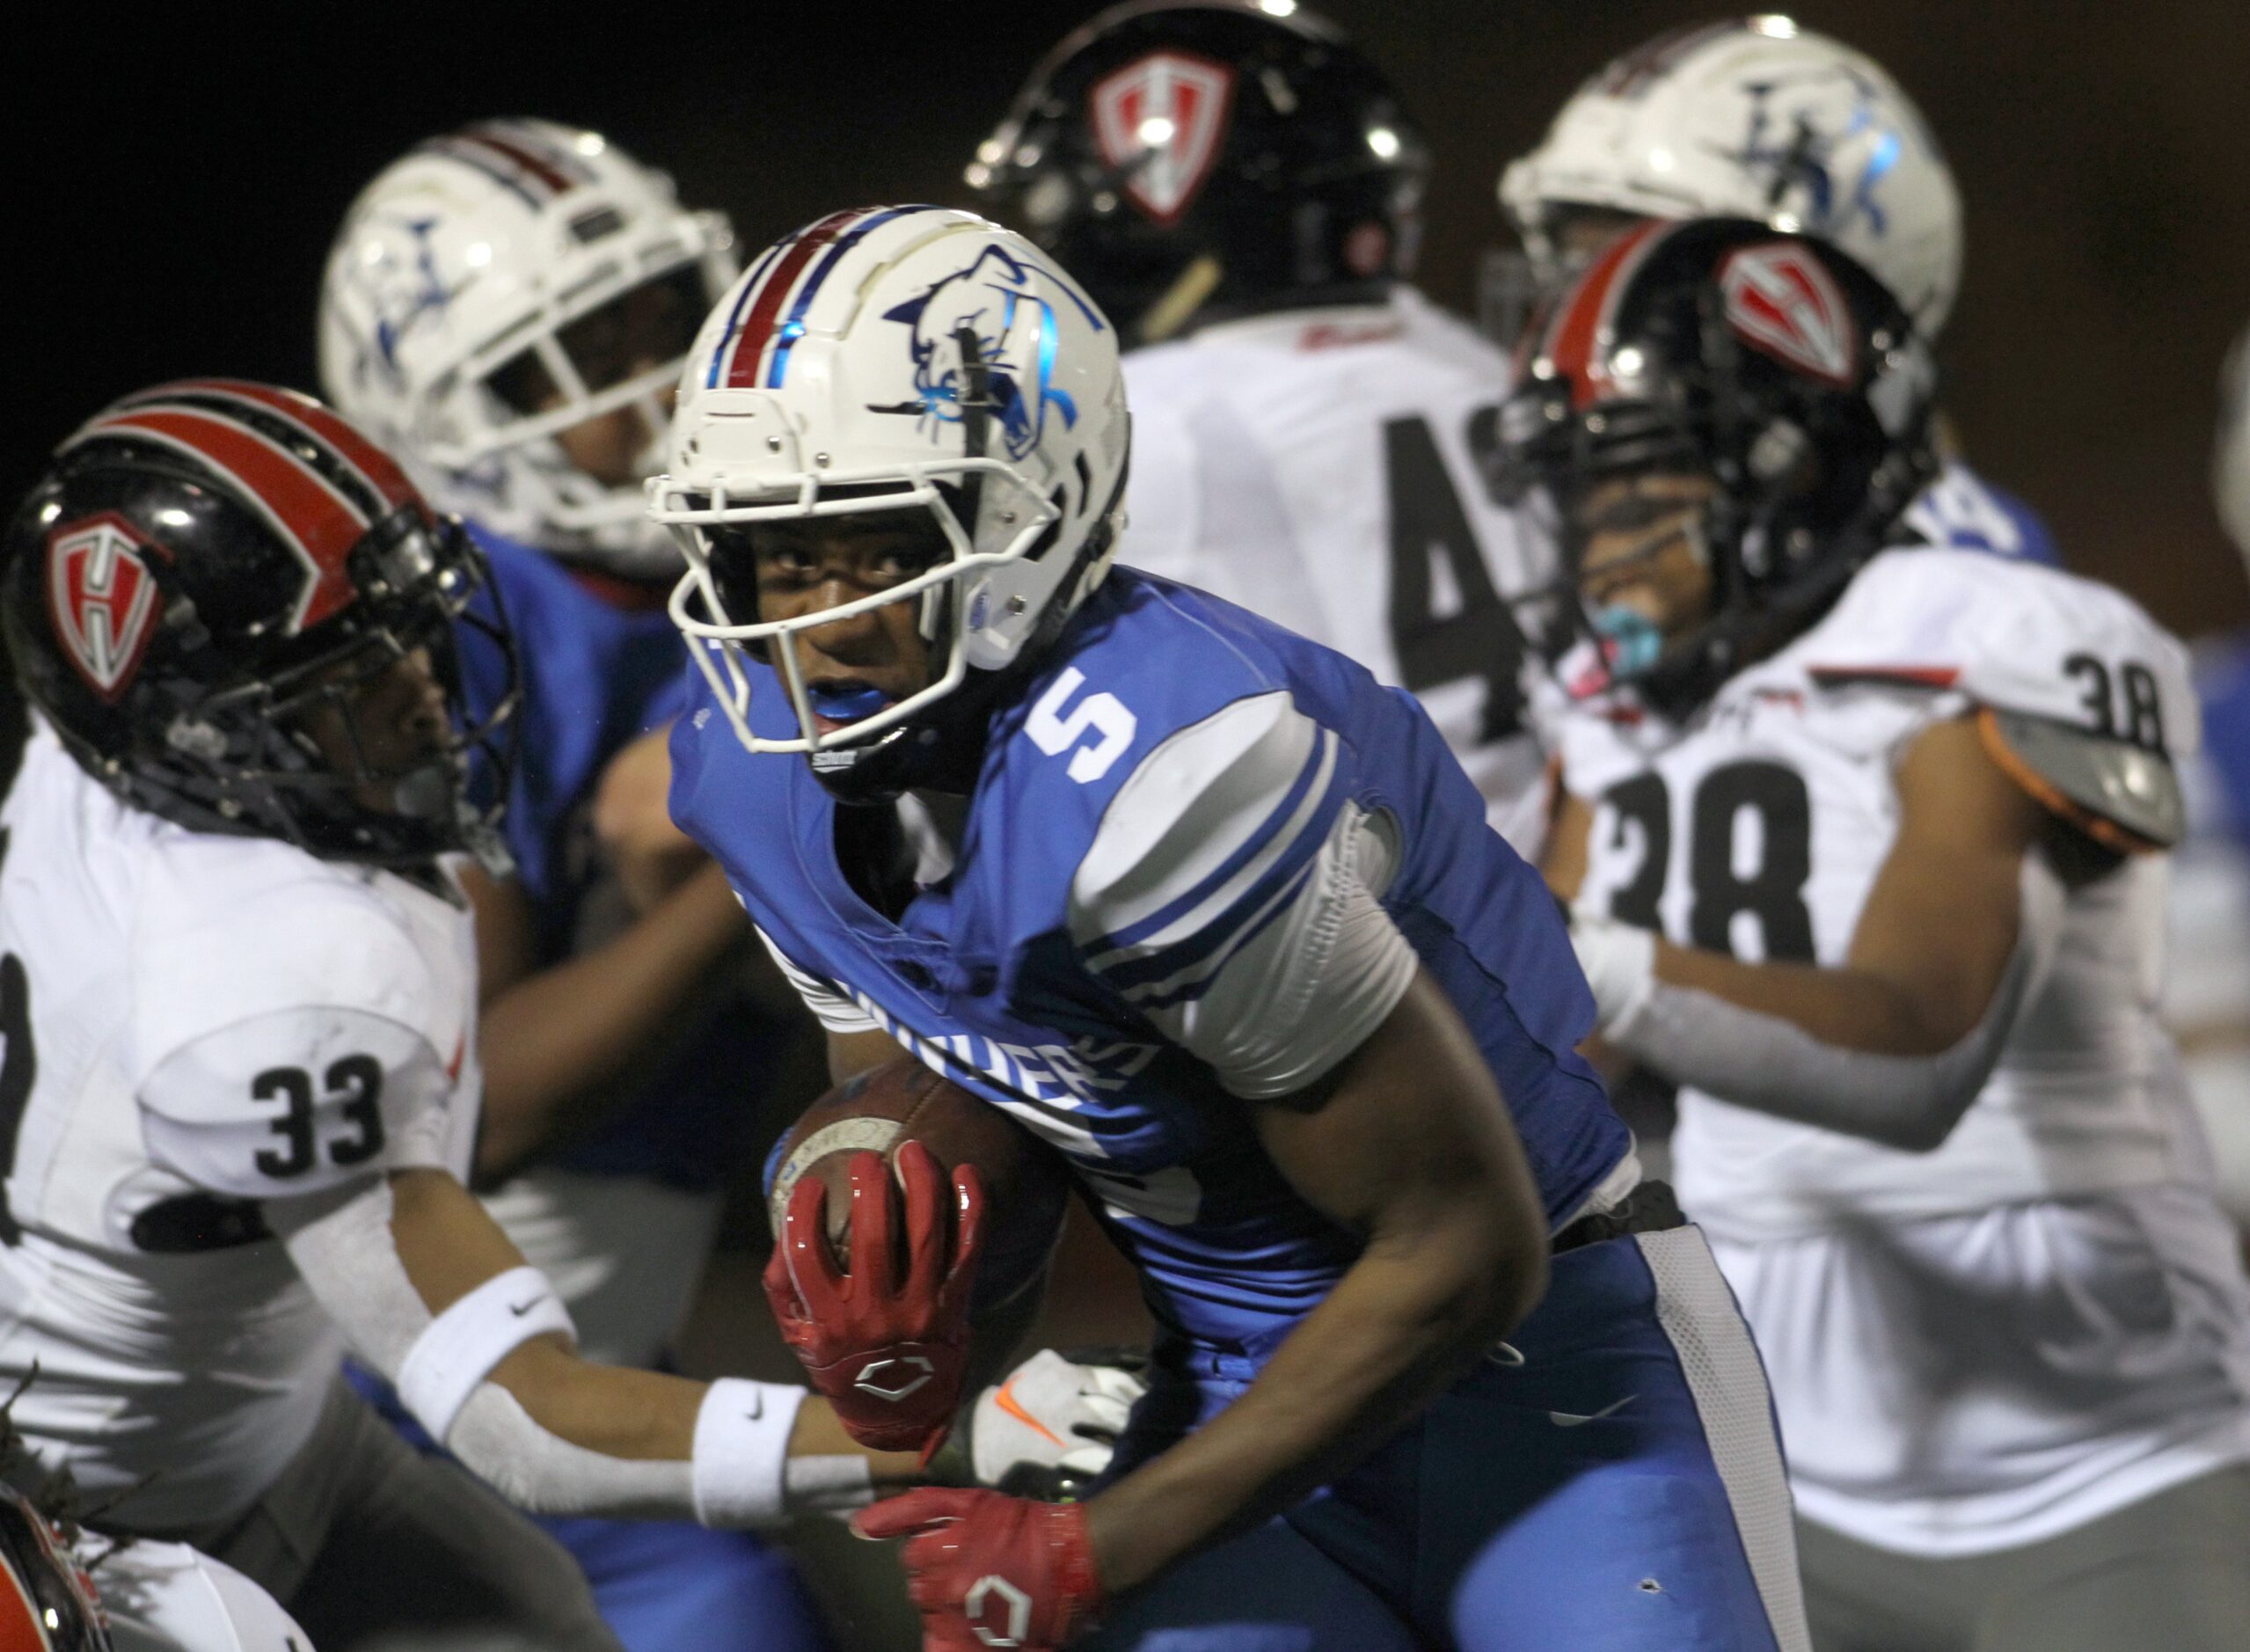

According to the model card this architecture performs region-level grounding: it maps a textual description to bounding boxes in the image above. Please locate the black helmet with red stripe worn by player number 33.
[0,378,515,866]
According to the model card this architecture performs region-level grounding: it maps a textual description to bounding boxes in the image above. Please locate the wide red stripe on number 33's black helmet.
[72,403,371,635]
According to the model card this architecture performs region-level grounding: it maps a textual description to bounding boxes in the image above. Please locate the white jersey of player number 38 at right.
[1561,549,2250,1553]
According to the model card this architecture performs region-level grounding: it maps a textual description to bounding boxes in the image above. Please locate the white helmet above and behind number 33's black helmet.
[319,120,738,579]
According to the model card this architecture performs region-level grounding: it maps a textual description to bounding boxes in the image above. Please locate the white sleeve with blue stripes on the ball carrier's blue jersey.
[1069,691,1418,1100]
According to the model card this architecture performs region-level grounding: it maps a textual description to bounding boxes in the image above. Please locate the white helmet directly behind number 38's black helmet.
[1501,16,1962,338]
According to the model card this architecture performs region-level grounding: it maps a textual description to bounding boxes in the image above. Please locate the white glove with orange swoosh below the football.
[969,1349,1148,1499]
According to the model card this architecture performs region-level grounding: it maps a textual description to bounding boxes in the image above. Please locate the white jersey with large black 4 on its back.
[1118,288,1552,853]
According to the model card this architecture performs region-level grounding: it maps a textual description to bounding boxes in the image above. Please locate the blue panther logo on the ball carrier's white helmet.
[884,247,1105,459]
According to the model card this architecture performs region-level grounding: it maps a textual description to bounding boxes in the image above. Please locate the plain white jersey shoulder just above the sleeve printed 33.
[130,833,457,1093]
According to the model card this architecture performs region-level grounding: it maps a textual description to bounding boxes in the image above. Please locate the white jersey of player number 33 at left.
[0,727,479,1535]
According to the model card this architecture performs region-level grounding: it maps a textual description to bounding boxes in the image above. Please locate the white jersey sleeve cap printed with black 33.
[137,1006,452,1197]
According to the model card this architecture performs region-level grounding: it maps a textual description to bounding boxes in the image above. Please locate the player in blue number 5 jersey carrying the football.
[650,207,1805,1652]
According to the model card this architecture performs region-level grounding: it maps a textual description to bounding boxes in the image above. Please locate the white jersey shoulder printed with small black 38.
[1789,547,2201,754]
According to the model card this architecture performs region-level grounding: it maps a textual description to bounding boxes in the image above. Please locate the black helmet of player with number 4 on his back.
[968,0,1428,344]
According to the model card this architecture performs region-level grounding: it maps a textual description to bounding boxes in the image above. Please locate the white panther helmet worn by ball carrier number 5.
[648,207,1129,767]
